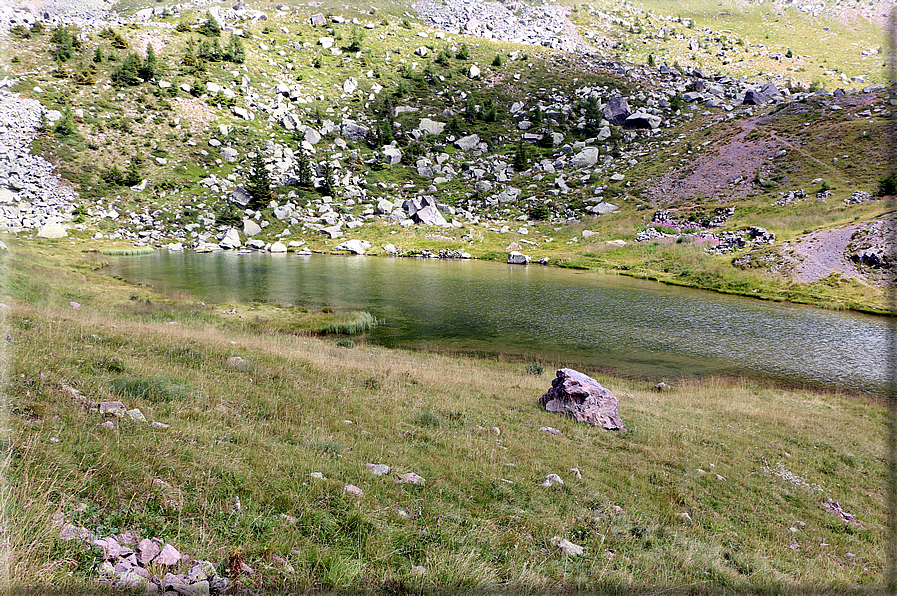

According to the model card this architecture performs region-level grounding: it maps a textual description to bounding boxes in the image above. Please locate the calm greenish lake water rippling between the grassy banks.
[110,251,894,393]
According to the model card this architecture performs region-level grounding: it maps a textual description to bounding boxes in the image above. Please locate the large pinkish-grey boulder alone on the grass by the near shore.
[539,368,625,430]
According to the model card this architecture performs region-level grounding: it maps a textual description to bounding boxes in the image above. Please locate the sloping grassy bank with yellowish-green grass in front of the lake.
[0,243,886,594]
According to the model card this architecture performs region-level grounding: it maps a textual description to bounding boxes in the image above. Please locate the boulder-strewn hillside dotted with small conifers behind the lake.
[0,0,897,308]
